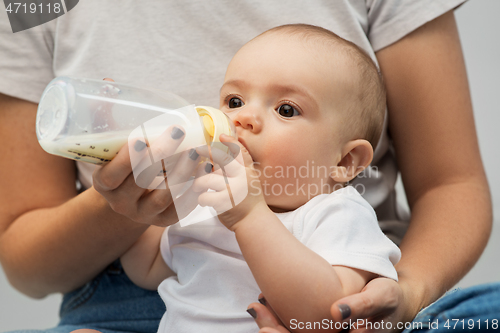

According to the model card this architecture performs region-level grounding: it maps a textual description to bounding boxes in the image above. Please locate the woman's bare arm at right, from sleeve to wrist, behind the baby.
[377,11,492,320]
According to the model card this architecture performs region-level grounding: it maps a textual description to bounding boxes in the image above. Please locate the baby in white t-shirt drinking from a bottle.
[90,25,401,333]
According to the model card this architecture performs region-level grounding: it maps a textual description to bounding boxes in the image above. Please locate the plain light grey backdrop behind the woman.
[0,0,500,332]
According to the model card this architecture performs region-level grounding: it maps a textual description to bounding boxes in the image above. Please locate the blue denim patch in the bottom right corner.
[403,282,500,333]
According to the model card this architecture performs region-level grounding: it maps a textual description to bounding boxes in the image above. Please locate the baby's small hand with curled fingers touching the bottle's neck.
[193,134,269,231]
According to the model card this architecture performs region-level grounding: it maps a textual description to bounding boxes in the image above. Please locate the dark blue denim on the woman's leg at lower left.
[5,260,165,333]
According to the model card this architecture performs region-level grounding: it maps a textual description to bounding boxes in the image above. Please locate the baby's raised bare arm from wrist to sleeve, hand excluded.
[234,209,375,332]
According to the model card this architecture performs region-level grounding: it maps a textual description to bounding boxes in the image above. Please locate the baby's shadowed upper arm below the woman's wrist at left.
[120,226,175,290]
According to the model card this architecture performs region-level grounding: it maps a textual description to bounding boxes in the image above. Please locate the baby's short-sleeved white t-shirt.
[158,186,401,333]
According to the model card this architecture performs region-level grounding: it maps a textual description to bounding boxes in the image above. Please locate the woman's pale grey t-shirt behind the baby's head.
[0,0,465,242]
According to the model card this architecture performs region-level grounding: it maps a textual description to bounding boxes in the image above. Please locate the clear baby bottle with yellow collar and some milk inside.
[36,77,236,165]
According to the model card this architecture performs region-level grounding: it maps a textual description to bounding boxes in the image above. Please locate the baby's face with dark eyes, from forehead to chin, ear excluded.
[220,33,354,211]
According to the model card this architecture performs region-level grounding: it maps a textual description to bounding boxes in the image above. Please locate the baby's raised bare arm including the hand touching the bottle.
[193,135,375,332]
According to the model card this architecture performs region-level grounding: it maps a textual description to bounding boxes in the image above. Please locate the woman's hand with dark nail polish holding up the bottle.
[92,79,200,227]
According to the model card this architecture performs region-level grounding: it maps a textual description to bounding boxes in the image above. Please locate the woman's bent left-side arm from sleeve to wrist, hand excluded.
[0,94,147,298]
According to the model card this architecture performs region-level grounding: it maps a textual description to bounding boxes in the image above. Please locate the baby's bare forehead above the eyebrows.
[225,29,370,102]
